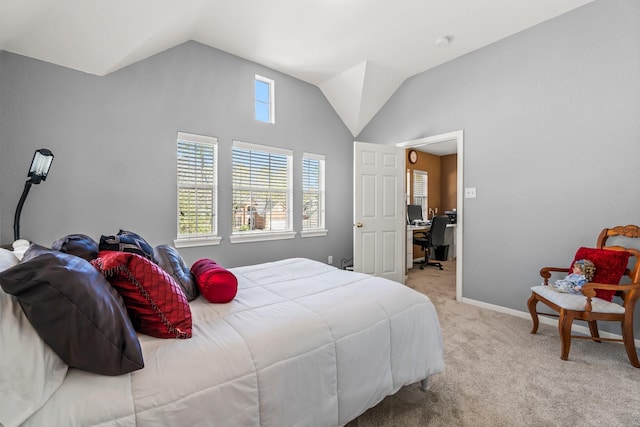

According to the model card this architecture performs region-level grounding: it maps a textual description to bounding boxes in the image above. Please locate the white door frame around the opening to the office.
[396,130,464,301]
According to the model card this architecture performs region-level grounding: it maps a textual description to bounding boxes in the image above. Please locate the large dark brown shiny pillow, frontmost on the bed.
[0,251,144,375]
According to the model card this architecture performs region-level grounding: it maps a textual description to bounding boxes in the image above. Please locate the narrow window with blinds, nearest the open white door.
[301,153,327,237]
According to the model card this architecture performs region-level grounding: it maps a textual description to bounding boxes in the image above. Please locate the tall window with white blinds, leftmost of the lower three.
[174,132,220,247]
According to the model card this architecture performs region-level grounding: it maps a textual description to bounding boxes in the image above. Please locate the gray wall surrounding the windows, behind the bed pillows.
[0,42,353,266]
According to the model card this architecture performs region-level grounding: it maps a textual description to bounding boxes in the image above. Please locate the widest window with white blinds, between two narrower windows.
[230,141,295,243]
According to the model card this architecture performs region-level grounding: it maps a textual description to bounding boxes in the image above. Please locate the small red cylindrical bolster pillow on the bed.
[191,258,238,303]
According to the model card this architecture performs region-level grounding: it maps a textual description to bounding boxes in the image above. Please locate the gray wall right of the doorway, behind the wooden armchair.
[357,0,640,337]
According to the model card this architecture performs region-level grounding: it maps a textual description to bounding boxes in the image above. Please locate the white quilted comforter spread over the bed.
[24,258,444,427]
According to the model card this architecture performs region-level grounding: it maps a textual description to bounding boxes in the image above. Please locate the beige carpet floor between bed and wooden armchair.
[347,262,640,427]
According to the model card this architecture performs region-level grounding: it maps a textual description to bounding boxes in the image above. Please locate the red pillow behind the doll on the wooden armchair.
[569,247,631,301]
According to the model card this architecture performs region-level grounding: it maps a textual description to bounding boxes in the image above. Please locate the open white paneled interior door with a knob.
[353,142,406,283]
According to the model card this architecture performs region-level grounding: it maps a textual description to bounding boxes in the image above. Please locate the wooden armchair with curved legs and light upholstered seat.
[527,225,640,368]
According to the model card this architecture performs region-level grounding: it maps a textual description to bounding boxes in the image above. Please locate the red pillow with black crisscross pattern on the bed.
[91,251,192,338]
